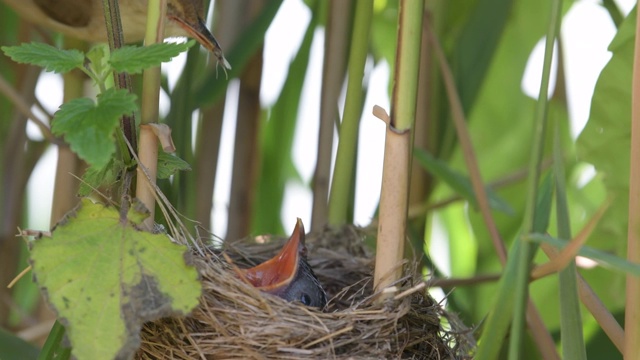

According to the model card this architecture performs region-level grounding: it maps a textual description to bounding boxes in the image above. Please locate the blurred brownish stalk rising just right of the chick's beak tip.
[311,0,354,231]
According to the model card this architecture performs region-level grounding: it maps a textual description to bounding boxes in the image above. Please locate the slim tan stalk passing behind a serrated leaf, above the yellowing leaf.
[136,0,167,231]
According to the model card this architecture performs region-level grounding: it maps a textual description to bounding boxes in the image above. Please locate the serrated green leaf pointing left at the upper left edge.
[1,43,84,73]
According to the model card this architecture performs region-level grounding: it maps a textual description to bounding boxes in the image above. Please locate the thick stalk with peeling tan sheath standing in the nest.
[373,0,424,296]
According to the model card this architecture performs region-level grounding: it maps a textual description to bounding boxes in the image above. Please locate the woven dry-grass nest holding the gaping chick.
[136,227,473,359]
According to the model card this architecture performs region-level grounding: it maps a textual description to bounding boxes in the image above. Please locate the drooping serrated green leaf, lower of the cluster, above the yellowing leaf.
[51,89,136,168]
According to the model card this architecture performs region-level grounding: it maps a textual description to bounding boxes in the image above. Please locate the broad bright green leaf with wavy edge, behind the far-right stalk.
[577,6,636,255]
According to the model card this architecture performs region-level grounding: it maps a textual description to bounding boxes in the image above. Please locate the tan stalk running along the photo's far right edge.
[624,2,640,360]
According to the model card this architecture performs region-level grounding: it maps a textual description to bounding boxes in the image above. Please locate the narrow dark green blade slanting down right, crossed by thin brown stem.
[413,148,514,215]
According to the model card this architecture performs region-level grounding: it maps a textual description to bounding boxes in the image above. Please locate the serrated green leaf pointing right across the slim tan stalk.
[109,41,194,74]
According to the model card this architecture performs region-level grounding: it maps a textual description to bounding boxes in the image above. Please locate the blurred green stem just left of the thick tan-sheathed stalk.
[329,0,373,226]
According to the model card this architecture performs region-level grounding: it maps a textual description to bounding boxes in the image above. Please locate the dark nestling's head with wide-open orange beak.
[229,219,327,308]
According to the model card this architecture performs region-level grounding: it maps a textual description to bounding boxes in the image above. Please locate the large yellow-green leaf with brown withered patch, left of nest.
[31,199,201,359]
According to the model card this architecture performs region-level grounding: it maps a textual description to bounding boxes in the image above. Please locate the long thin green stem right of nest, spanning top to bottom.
[509,0,562,360]
